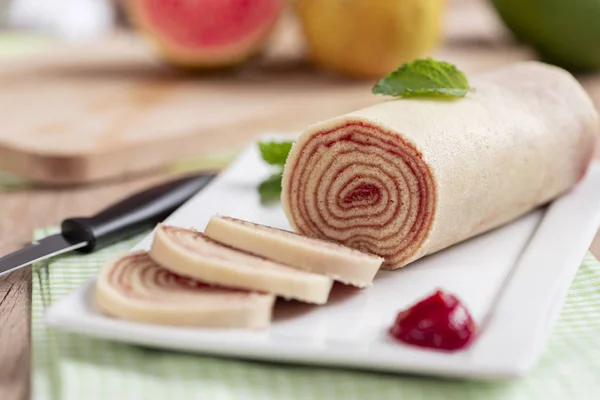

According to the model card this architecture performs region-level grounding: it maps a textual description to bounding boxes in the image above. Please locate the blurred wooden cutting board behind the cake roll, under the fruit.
[0,18,592,184]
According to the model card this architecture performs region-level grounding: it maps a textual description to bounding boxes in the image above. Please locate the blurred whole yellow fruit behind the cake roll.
[295,0,444,78]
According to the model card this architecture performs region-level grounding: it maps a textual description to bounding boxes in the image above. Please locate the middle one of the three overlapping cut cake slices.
[149,225,333,304]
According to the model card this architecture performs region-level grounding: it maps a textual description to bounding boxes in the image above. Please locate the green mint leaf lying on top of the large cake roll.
[372,58,470,97]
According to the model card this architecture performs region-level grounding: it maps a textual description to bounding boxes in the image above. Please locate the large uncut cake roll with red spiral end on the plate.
[282,62,598,269]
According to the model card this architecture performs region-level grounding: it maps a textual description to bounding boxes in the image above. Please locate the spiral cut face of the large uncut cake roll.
[282,121,436,265]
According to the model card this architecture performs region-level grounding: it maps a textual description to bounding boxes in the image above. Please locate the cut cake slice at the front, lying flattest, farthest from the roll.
[95,252,275,328]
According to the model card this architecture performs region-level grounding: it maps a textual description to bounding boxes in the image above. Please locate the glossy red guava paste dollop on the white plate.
[389,290,478,351]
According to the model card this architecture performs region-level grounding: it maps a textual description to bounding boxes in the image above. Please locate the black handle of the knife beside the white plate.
[61,174,215,253]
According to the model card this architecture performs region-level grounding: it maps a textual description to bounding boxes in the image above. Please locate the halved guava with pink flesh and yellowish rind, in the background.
[126,0,284,68]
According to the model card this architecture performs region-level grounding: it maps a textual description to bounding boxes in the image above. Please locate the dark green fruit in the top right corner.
[493,0,600,71]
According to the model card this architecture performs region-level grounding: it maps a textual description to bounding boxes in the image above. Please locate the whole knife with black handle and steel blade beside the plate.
[0,174,215,276]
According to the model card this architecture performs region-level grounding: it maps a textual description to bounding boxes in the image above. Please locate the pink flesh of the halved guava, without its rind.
[142,0,281,48]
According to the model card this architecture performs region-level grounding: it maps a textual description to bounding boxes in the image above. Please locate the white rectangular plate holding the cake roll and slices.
[47,146,600,379]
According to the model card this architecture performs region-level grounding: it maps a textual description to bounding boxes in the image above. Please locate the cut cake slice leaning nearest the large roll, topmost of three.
[204,216,383,287]
